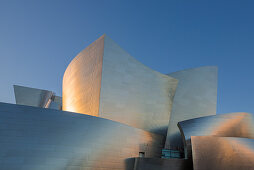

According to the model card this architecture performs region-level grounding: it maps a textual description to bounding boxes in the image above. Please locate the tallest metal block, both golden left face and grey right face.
[63,35,178,135]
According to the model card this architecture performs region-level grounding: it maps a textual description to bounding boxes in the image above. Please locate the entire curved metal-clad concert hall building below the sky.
[0,35,254,170]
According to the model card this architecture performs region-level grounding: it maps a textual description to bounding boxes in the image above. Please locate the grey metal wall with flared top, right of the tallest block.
[165,66,217,150]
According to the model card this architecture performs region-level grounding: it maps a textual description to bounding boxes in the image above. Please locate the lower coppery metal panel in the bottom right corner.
[191,136,254,170]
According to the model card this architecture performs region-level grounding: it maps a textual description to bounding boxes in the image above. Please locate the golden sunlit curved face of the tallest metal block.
[62,36,104,116]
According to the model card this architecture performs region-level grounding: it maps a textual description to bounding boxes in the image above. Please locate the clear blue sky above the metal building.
[0,0,254,113]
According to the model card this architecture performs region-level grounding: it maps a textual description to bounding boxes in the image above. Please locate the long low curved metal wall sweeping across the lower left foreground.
[0,103,163,170]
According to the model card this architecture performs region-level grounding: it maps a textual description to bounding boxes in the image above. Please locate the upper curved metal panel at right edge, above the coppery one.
[178,112,254,157]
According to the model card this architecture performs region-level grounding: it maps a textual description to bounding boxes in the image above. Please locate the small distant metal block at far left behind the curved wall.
[13,85,62,110]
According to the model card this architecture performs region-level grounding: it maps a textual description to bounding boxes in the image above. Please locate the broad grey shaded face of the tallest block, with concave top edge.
[99,36,177,135]
